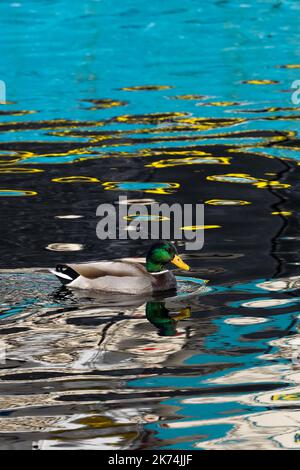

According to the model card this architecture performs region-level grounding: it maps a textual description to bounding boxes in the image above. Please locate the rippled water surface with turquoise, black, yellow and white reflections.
[0,0,300,450]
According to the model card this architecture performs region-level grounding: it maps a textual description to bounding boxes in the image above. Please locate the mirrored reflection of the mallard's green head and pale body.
[64,299,191,370]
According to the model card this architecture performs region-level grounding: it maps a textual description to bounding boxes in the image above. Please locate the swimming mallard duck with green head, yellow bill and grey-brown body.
[50,242,190,295]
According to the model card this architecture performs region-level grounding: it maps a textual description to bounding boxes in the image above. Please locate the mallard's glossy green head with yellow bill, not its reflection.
[146,242,190,273]
